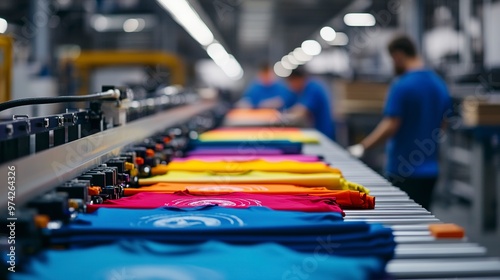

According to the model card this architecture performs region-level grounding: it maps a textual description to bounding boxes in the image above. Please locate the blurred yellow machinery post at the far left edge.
[0,35,13,102]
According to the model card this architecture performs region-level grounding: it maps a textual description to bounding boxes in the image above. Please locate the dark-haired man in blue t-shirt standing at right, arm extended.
[349,36,451,209]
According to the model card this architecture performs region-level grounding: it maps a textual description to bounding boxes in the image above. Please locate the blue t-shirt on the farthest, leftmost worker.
[242,81,297,110]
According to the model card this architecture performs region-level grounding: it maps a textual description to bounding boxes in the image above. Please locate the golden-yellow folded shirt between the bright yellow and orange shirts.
[139,171,369,193]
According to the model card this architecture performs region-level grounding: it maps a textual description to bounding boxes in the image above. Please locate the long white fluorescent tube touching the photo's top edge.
[157,0,214,46]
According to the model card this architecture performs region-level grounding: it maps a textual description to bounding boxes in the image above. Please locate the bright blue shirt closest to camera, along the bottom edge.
[12,240,385,280]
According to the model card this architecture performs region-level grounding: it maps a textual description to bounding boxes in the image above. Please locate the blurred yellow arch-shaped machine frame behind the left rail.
[62,51,186,95]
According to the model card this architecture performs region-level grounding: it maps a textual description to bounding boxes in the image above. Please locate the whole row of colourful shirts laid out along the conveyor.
[29,128,395,279]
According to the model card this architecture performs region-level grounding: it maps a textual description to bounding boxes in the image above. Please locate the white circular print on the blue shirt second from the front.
[131,213,244,228]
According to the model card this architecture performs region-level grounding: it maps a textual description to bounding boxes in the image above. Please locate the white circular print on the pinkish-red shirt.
[165,197,262,207]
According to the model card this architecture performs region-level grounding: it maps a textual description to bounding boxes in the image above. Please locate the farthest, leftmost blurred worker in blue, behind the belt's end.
[236,64,296,110]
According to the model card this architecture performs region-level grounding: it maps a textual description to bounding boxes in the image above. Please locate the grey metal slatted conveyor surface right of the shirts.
[304,130,500,279]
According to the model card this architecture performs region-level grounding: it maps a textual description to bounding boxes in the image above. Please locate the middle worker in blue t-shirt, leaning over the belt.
[283,67,335,139]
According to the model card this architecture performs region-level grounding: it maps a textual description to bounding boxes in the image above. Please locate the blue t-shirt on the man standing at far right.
[384,69,451,178]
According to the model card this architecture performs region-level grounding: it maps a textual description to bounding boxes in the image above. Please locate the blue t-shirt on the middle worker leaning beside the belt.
[298,80,335,139]
